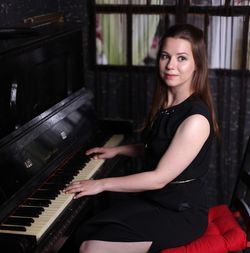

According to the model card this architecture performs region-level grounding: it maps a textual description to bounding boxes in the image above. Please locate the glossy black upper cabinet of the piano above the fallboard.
[0,24,83,138]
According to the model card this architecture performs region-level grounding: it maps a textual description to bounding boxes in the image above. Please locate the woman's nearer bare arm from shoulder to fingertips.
[66,114,210,198]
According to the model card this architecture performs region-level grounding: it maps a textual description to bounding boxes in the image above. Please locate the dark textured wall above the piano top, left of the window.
[0,0,93,87]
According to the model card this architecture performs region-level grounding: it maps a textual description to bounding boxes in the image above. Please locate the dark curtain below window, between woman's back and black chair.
[207,71,250,205]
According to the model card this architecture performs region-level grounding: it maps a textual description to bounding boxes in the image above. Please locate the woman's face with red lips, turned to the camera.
[159,37,195,91]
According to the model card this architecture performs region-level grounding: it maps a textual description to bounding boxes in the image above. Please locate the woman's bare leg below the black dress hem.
[80,240,152,253]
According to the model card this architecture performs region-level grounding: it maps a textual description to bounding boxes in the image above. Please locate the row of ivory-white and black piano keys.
[0,134,124,241]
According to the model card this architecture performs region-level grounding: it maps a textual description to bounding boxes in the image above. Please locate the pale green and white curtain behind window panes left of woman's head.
[96,14,160,65]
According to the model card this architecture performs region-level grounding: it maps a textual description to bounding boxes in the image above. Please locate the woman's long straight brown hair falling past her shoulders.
[146,24,219,135]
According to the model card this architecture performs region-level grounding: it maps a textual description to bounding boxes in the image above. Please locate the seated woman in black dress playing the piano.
[65,24,218,253]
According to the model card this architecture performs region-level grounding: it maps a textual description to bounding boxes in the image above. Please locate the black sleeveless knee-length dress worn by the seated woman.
[73,95,213,253]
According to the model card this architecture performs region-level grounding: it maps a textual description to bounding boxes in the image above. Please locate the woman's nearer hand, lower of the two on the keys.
[63,180,103,199]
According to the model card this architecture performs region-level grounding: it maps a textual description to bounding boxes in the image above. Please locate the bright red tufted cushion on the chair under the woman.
[160,205,247,253]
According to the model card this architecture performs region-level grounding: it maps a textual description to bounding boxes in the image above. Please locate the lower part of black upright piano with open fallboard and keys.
[0,88,132,253]
